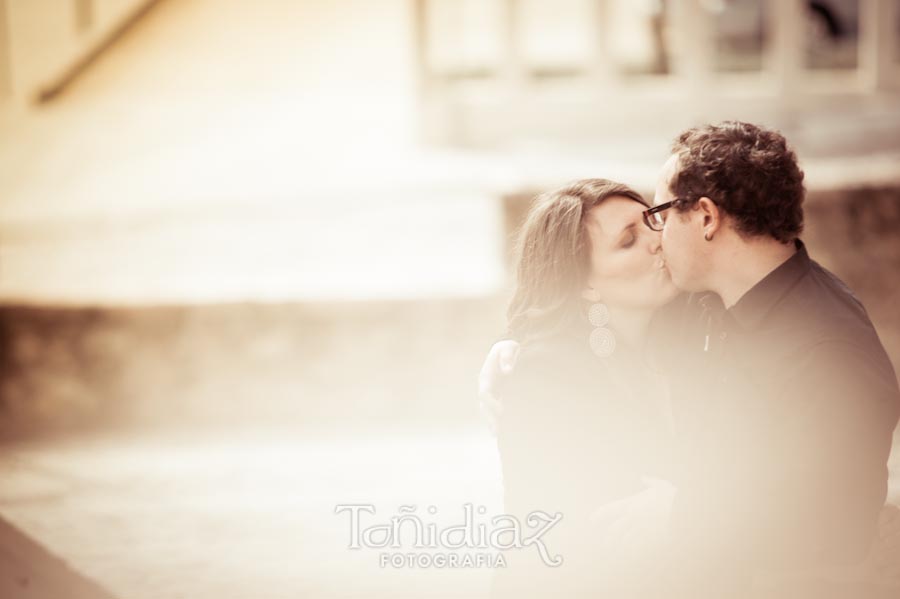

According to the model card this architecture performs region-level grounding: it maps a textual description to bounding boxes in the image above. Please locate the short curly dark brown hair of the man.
[669,121,806,243]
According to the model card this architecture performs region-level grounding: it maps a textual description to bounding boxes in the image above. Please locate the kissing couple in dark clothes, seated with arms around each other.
[479,122,900,599]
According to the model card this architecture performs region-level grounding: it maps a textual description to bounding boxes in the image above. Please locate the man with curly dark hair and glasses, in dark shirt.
[645,122,900,596]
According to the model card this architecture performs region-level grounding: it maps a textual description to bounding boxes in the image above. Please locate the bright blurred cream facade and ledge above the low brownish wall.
[0,0,900,303]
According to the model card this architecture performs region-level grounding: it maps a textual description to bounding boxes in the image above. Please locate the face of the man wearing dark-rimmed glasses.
[653,155,709,291]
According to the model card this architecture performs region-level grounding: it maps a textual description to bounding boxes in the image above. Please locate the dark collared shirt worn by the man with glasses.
[654,241,900,579]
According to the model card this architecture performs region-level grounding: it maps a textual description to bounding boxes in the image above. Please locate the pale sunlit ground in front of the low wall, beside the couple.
[0,432,500,599]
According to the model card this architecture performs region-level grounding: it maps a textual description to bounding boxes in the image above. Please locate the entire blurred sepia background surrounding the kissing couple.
[0,0,900,599]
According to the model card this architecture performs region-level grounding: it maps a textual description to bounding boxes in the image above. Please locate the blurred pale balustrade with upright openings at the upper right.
[416,0,900,153]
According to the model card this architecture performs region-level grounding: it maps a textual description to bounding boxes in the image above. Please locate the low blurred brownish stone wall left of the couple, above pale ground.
[0,298,502,436]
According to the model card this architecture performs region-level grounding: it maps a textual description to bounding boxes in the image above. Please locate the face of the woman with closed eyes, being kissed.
[585,196,678,309]
